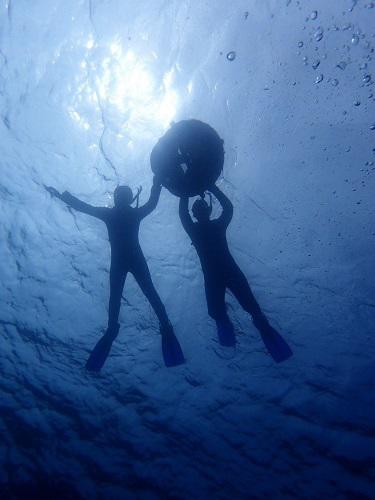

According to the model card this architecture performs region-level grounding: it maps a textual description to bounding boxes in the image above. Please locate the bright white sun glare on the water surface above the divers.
[69,37,178,135]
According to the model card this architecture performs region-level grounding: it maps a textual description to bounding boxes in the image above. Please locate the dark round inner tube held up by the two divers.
[150,120,224,196]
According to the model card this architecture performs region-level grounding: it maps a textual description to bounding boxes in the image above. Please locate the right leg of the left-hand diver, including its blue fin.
[130,255,185,367]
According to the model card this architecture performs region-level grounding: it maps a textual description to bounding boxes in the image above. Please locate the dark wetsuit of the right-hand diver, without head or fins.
[180,187,264,321]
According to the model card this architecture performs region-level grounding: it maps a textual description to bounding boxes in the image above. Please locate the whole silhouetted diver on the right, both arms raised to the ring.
[179,185,292,362]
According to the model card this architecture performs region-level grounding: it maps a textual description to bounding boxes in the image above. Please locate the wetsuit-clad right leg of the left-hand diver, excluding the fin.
[129,255,169,327]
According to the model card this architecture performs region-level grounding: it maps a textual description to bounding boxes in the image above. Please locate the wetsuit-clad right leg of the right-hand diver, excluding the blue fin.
[226,264,268,326]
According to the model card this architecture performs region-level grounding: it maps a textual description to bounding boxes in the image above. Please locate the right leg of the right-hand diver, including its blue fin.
[227,264,293,363]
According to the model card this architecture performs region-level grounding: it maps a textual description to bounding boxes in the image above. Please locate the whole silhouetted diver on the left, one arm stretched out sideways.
[46,177,184,371]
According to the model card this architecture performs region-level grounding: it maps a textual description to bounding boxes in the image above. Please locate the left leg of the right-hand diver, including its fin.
[204,276,236,347]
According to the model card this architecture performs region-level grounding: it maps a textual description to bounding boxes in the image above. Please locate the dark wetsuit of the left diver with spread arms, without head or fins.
[61,186,169,328]
